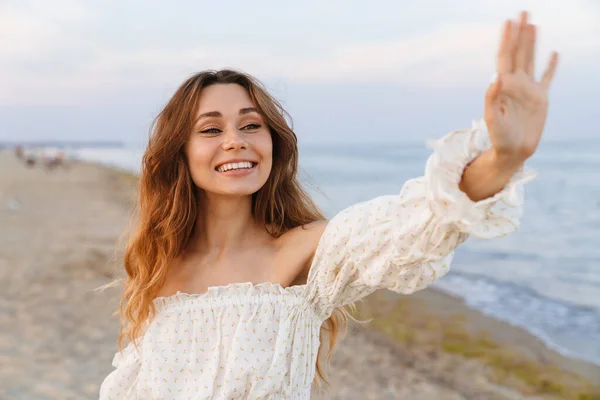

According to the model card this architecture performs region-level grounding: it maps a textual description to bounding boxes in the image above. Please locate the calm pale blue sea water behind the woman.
[73,140,600,365]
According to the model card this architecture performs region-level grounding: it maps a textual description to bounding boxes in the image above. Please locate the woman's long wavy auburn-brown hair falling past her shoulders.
[119,70,349,384]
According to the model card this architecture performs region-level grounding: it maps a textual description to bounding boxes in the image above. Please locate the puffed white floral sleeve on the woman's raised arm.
[305,120,535,318]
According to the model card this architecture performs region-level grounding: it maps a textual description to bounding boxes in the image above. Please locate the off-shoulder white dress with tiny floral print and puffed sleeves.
[100,120,533,400]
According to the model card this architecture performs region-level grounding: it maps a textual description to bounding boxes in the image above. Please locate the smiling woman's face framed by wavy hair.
[185,84,273,196]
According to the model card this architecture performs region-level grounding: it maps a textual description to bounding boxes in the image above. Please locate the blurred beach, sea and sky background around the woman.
[0,0,600,399]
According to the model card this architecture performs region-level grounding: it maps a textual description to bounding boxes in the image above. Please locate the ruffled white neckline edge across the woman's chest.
[153,282,307,308]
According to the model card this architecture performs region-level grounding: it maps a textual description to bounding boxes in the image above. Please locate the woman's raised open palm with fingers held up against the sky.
[484,12,558,160]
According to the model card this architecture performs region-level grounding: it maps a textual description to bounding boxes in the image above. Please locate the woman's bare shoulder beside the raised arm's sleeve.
[278,220,328,284]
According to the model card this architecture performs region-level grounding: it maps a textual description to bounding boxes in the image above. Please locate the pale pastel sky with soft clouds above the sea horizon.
[0,0,600,143]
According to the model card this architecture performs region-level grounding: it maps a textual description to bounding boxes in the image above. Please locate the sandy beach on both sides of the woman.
[0,151,600,400]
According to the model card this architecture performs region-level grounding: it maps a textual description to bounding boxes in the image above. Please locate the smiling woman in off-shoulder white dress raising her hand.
[100,13,557,399]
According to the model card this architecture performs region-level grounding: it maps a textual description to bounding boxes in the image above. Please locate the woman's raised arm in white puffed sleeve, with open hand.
[304,9,557,318]
